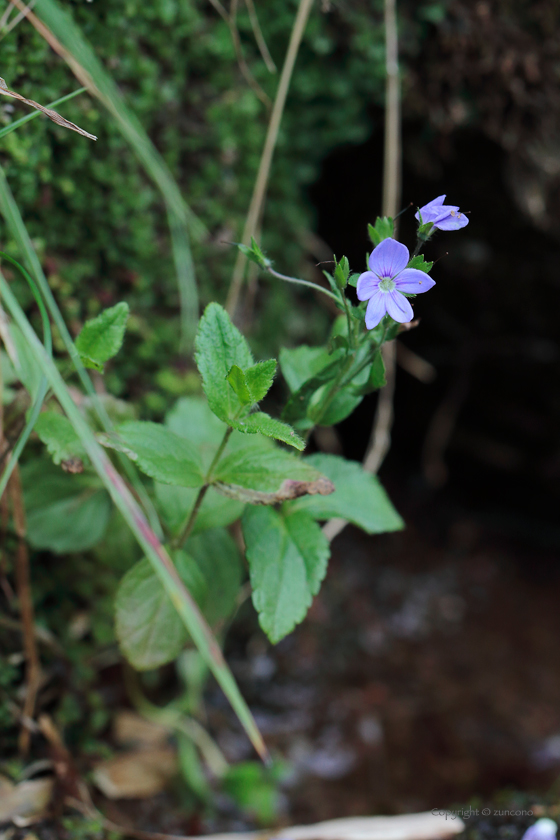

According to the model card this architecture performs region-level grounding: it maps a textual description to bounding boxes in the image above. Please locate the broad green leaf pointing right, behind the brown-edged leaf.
[286,454,404,534]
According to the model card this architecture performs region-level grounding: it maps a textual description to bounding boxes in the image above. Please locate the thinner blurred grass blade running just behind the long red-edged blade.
[0,166,163,537]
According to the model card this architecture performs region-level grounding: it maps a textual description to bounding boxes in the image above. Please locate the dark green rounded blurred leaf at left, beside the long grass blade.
[21,459,111,554]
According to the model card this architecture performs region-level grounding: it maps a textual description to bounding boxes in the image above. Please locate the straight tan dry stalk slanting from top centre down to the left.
[226,0,313,315]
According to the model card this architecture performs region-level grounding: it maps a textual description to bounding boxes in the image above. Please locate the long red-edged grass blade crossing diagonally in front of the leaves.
[0,274,268,760]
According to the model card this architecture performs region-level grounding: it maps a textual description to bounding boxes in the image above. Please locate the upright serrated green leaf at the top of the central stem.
[195,303,253,423]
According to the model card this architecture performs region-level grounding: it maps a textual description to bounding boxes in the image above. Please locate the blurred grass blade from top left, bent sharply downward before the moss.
[14,0,205,348]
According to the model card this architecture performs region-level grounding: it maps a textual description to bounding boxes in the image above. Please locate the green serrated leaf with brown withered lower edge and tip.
[214,449,332,504]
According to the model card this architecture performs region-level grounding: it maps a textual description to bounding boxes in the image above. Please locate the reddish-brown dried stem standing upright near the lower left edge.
[8,467,41,755]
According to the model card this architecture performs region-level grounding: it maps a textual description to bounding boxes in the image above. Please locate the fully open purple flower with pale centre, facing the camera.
[356,239,435,330]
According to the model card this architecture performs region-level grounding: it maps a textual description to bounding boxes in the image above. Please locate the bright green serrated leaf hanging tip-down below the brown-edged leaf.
[243,507,330,643]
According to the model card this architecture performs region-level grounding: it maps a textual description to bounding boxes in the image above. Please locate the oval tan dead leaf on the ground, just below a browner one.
[93,747,178,799]
